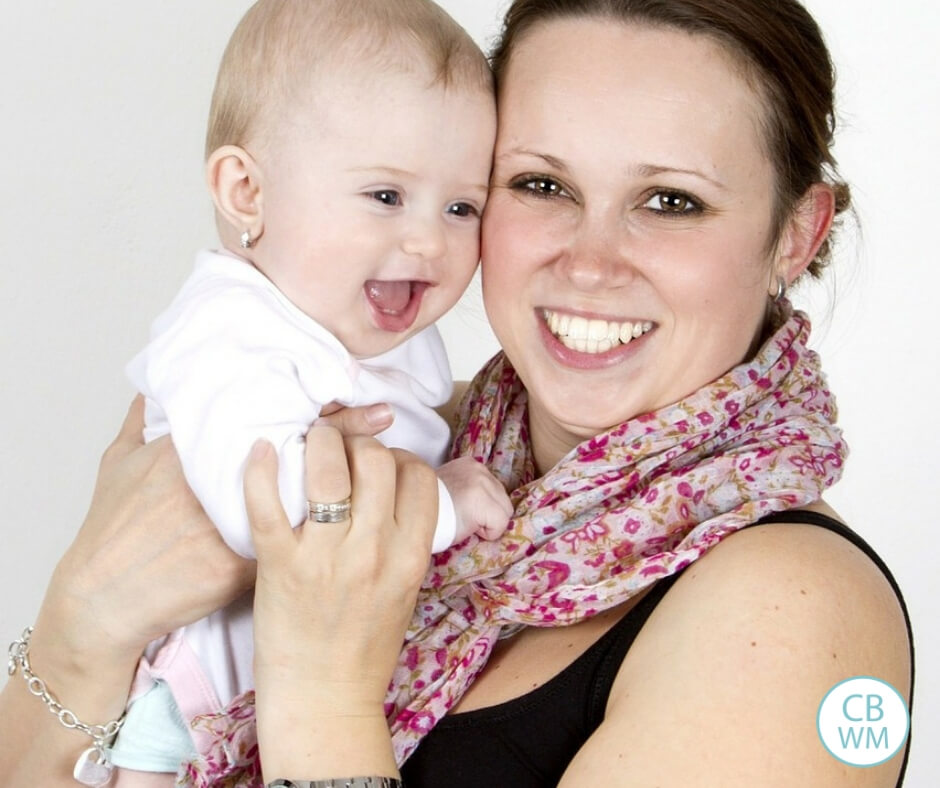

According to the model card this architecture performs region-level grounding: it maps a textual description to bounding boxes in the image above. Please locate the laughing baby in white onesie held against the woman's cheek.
[112,0,512,785]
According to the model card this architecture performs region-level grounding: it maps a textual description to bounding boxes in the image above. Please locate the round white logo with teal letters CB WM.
[816,676,911,766]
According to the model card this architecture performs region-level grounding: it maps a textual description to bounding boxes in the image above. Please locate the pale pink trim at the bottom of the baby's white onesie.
[130,629,222,753]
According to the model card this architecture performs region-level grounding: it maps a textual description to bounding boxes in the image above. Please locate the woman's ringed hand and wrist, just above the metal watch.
[245,426,437,780]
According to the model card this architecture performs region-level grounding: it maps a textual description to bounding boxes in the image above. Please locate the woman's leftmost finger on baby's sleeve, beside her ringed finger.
[245,439,294,561]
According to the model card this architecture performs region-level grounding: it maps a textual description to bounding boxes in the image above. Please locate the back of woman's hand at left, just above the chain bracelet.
[33,396,254,705]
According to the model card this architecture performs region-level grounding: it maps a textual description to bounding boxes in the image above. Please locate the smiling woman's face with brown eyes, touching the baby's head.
[482,19,775,465]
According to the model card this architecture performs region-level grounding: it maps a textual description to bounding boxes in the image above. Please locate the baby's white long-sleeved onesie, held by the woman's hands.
[115,251,456,768]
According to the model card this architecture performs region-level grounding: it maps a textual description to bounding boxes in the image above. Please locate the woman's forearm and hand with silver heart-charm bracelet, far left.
[0,398,254,788]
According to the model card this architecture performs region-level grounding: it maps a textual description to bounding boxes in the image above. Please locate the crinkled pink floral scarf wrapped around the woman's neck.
[179,305,847,788]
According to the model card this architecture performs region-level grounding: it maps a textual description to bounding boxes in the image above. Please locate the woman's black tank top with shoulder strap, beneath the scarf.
[401,510,914,788]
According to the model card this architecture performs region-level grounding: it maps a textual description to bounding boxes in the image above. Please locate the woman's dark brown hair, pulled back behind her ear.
[490,0,851,276]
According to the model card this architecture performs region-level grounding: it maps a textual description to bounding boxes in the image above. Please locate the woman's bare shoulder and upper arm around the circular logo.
[562,503,910,786]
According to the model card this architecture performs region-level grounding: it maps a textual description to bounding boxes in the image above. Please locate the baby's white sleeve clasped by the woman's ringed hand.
[128,285,351,557]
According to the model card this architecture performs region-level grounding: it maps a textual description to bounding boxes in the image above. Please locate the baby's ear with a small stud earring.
[206,145,264,241]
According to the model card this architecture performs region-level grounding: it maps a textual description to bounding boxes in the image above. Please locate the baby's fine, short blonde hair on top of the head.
[206,0,492,157]
